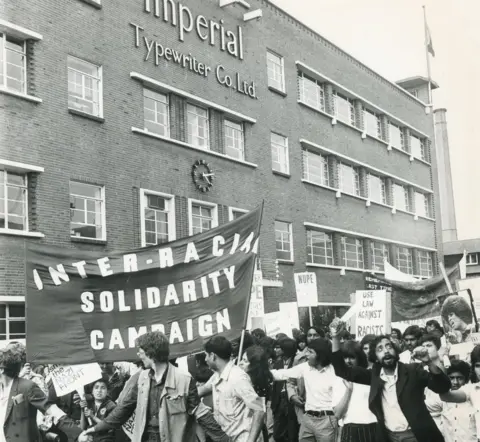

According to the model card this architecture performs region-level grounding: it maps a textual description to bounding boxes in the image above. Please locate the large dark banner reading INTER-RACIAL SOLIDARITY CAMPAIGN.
[26,205,263,364]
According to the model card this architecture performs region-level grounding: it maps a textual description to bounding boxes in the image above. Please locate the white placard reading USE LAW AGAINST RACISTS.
[355,290,387,340]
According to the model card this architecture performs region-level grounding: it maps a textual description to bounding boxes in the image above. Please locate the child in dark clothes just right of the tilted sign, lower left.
[80,378,116,442]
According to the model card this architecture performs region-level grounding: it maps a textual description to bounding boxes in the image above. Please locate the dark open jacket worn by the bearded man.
[332,351,451,442]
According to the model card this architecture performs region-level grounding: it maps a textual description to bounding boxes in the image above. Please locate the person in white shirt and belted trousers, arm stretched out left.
[272,338,337,442]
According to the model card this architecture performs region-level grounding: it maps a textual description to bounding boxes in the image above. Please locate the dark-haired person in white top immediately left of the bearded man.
[333,341,377,442]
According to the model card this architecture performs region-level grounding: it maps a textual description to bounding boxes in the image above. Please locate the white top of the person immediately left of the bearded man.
[332,378,377,426]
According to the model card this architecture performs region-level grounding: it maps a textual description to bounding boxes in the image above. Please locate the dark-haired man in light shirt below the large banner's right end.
[198,336,265,442]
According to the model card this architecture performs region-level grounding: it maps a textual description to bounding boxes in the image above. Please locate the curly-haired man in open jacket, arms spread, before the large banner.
[84,331,229,442]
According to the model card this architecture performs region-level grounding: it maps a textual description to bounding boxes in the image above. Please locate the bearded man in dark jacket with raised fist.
[330,319,451,442]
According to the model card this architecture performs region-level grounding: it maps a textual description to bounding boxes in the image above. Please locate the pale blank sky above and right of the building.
[272,0,480,239]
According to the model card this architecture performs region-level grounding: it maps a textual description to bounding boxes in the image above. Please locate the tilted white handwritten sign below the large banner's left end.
[51,363,102,397]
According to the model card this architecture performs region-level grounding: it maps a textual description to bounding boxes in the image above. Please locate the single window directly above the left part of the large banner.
[70,181,106,240]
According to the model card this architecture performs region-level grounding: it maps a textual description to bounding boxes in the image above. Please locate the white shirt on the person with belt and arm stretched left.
[272,362,340,411]
